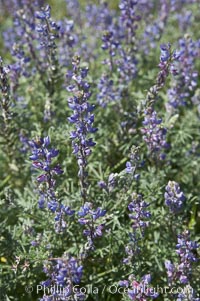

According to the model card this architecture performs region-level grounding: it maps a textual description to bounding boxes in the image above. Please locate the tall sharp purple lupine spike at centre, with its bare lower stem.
[68,56,97,203]
